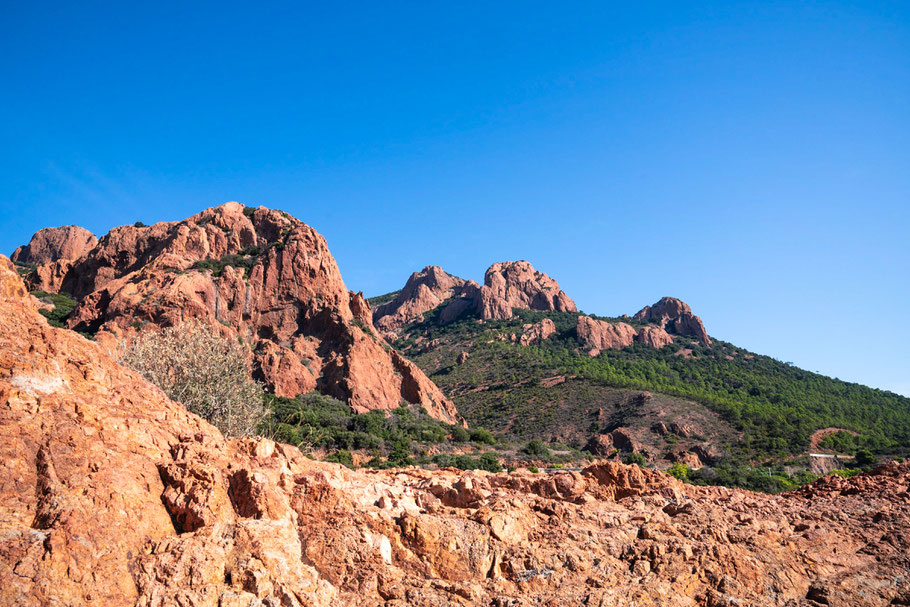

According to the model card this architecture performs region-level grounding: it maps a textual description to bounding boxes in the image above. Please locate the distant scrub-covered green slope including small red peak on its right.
[378,264,910,468]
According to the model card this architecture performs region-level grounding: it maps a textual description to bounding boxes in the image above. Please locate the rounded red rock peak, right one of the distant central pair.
[440,261,577,323]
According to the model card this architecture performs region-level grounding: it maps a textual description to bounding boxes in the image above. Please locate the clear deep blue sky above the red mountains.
[0,1,910,394]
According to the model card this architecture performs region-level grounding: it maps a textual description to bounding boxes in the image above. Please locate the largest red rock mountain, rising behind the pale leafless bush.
[29,202,457,423]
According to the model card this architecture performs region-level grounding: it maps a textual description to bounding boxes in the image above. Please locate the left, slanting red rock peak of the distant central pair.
[373,266,465,333]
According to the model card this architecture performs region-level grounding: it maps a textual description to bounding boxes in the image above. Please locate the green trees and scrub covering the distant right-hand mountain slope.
[394,309,910,465]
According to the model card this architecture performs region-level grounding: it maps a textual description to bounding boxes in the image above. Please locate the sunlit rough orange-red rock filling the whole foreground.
[0,258,910,607]
